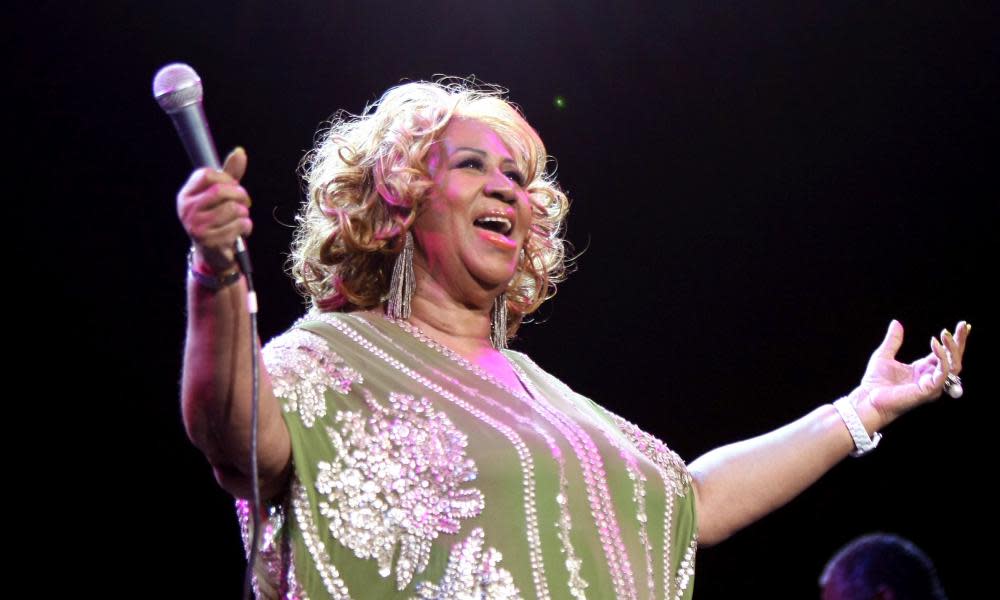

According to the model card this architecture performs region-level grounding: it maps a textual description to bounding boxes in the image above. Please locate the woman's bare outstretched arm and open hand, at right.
[689,321,969,545]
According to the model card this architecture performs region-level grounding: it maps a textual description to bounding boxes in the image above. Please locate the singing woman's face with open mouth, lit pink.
[413,119,532,302]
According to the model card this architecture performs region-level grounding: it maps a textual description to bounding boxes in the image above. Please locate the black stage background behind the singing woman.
[21,0,1000,600]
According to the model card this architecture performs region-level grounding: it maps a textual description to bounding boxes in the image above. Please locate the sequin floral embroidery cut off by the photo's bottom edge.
[415,527,521,600]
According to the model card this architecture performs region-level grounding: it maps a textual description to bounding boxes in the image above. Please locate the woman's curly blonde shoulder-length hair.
[290,78,569,337]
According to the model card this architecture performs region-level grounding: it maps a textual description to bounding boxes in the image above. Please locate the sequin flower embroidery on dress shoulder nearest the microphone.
[261,329,364,427]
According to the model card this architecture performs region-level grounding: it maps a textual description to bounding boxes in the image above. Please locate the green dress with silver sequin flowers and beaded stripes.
[237,313,697,600]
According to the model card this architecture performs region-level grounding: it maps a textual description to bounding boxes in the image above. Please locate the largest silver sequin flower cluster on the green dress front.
[316,390,484,590]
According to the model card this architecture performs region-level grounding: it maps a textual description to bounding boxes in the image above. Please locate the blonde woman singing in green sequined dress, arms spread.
[177,82,970,599]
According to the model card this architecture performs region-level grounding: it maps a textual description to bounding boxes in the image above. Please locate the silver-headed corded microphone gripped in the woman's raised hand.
[153,63,252,270]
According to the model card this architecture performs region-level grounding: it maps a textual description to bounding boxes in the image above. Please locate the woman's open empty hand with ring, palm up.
[859,320,971,427]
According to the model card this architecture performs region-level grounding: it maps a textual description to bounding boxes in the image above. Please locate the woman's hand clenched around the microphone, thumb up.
[177,148,253,274]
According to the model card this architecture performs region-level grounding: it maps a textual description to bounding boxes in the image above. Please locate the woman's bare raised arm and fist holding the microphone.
[177,149,291,498]
